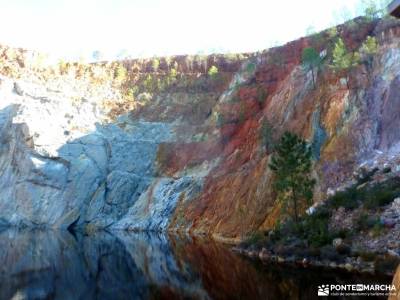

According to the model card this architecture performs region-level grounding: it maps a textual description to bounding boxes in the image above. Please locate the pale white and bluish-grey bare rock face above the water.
[0,78,202,229]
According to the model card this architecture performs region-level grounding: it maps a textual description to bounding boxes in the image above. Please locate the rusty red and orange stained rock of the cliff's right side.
[133,20,400,241]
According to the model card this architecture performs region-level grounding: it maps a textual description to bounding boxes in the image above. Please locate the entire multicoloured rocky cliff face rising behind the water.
[0,20,400,240]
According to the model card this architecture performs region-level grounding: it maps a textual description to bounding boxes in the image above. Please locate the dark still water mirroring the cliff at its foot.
[0,230,390,300]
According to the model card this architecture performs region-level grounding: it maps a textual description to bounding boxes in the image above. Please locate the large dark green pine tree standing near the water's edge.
[269,132,315,223]
